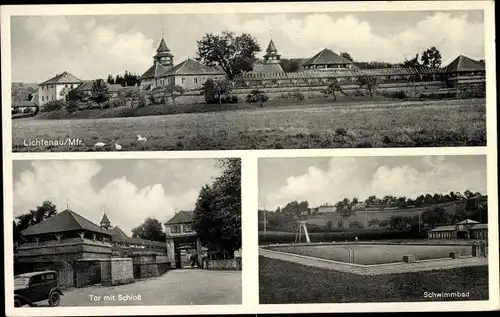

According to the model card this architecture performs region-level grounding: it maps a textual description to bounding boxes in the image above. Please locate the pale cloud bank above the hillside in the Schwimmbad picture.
[260,156,486,209]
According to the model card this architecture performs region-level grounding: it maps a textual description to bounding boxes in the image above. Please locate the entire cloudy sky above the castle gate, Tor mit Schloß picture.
[13,159,222,235]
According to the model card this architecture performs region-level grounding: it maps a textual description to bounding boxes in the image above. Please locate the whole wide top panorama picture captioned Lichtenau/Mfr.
[11,10,487,152]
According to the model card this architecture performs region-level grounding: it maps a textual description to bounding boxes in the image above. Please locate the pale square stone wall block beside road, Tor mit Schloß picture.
[101,258,134,286]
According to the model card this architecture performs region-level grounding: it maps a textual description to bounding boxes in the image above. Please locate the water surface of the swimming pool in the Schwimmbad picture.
[271,245,472,265]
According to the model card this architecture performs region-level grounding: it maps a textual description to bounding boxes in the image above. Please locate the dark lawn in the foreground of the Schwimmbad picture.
[259,257,488,304]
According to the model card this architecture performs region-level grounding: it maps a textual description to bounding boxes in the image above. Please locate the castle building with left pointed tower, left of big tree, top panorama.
[139,37,225,90]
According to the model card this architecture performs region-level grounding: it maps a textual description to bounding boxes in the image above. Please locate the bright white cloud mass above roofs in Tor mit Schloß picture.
[14,160,214,233]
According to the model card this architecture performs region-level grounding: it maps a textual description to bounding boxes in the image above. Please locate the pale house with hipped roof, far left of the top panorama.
[38,72,83,107]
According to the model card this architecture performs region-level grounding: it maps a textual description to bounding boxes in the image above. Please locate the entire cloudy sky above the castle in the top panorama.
[11,11,484,83]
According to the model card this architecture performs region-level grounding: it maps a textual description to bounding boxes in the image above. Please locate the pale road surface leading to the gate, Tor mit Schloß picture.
[39,269,242,307]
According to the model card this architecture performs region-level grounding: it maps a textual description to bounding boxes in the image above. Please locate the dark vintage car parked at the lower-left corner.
[14,271,63,307]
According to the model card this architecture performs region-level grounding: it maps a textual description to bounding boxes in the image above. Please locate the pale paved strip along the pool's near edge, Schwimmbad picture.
[259,248,488,275]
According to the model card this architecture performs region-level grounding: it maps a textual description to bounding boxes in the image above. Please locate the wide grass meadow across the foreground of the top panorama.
[12,99,486,152]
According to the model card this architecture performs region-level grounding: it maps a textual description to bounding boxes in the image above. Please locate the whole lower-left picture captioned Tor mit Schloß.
[10,158,242,307]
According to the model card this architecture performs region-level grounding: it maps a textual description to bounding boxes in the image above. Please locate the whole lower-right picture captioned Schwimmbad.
[258,155,489,304]
